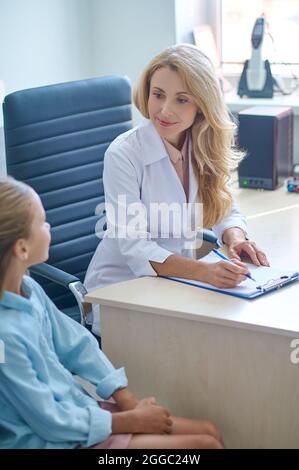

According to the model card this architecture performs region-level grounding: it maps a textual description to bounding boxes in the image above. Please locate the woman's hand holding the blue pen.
[200,259,248,289]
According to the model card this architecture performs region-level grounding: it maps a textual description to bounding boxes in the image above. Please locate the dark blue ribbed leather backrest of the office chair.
[3,76,132,308]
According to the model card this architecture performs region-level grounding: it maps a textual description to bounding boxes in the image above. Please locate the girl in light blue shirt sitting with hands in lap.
[0,178,223,449]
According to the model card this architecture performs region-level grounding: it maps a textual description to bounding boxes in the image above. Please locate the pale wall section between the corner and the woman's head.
[92,0,176,122]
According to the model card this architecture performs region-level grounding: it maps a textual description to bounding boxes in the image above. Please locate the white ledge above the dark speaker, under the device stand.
[225,92,299,163]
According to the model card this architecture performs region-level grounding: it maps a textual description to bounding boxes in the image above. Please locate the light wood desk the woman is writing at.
[87,189,299,448]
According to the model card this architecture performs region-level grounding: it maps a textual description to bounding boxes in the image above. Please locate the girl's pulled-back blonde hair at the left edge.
[0,177,34,298]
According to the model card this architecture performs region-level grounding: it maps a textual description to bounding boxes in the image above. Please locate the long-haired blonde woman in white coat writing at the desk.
[85,45,268,334]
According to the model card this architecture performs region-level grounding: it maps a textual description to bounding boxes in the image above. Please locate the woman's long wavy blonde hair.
[133,44,243,227]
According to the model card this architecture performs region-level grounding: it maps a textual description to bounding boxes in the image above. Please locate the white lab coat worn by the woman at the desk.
[85,120,247,334]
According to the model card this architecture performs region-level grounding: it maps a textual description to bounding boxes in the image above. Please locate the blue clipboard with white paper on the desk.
[161,253,299,300]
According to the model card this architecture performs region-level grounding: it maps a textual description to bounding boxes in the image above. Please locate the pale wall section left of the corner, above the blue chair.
[0,0,92,175]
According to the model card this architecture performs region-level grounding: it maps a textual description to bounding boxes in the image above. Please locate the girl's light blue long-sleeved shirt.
[0,276,127,449]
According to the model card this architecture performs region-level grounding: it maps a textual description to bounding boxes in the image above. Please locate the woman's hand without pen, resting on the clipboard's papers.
[222,227,270,266]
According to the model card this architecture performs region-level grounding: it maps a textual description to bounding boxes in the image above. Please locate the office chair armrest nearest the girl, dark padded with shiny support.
[30,263,92,325]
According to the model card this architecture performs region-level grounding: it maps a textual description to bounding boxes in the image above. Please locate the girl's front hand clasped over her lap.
[133,398,172,434]
